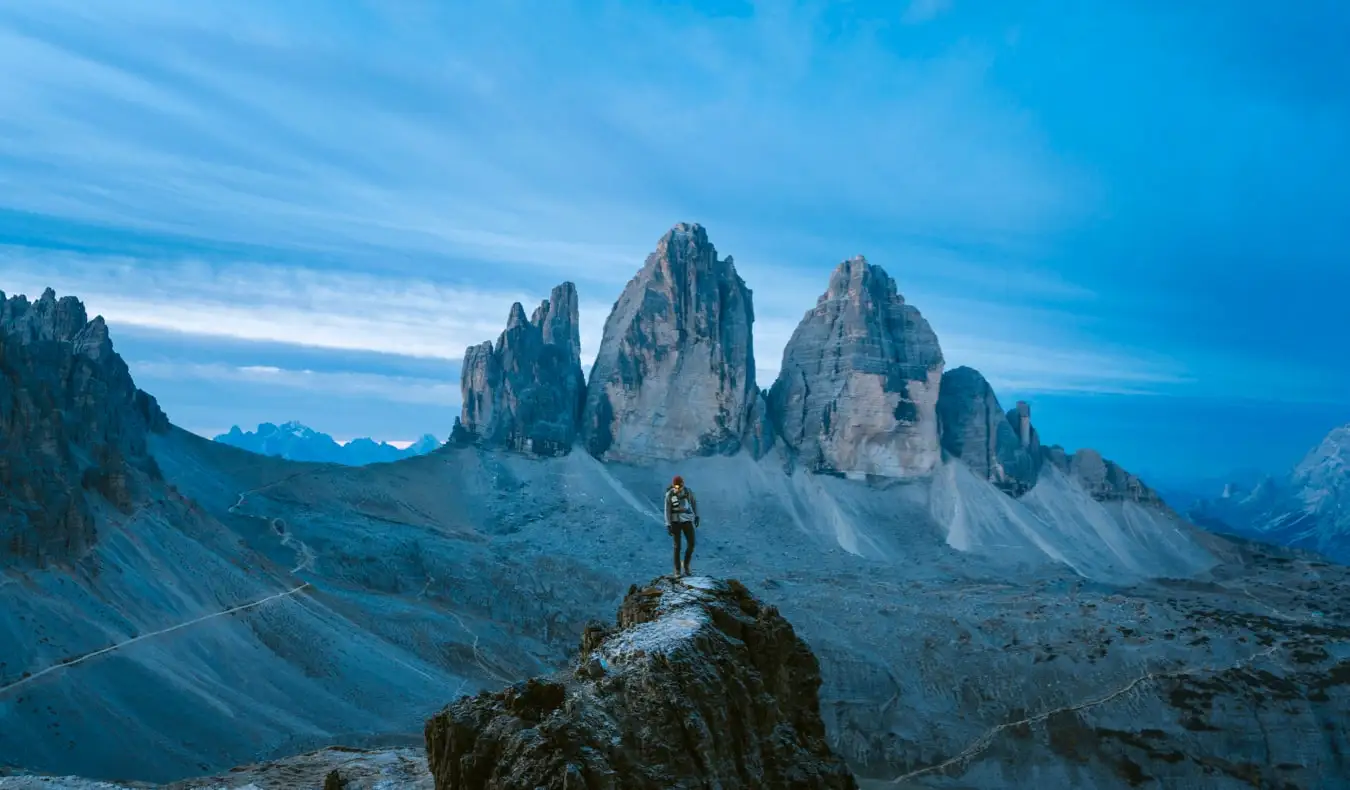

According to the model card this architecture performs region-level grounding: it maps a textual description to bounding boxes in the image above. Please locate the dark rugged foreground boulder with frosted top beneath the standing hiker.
[425,577,857,790]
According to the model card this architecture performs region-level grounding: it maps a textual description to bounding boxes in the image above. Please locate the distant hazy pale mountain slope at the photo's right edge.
[1187,425,1350,563]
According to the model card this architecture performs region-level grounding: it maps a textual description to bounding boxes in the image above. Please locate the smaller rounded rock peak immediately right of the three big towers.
[937,366,1041,497]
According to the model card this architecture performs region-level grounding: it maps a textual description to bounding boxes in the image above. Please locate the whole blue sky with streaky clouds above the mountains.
[0,0,1350,477]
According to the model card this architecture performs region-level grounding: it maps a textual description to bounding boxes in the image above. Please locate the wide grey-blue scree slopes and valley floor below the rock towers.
[0,431,1350,790]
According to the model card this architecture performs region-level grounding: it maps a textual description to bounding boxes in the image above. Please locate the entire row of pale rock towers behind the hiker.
[452,223,1162,506]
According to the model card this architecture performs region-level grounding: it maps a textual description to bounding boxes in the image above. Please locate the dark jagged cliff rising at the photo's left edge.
[0,289,169,566]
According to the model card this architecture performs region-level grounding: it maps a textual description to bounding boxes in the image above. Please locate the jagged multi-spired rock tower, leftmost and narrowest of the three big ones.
[454,282,586,455]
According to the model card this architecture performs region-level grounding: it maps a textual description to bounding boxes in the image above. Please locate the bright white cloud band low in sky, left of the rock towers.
[0,247,609,362]
